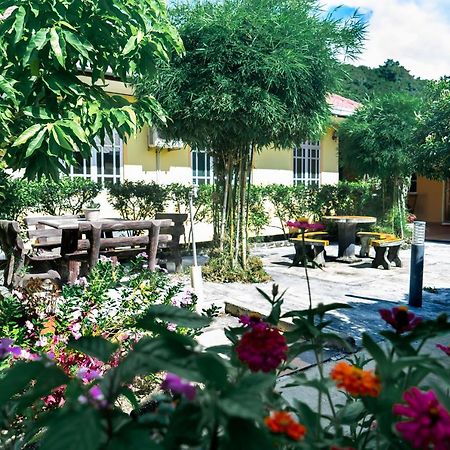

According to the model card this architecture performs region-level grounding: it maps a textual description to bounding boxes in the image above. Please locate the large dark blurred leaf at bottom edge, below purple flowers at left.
[39,407,106,450]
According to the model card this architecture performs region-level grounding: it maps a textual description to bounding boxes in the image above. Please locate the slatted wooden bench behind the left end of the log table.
[24,215,79,250]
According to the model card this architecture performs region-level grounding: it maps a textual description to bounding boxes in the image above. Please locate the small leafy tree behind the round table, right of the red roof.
[339,94,420,235]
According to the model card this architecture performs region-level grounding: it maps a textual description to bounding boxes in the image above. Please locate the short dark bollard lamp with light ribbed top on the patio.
[408,220,426,308]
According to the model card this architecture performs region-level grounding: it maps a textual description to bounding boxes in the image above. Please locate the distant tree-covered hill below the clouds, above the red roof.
[335,59,426,103]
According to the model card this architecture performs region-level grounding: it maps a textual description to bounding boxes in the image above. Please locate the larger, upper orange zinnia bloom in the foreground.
[331,361,381,397]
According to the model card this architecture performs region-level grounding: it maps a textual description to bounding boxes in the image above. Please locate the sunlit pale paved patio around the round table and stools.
[198,242,450,343]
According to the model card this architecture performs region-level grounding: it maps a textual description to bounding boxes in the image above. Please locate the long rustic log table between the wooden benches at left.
[39,218,172,281]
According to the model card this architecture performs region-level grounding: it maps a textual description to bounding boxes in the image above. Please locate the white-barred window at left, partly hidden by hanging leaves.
[70,131,123,186]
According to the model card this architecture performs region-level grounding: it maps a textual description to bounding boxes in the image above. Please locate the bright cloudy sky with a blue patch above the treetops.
[321,0,450,79]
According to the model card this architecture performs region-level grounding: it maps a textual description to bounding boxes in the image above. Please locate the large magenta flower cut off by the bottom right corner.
[393,387,450,450]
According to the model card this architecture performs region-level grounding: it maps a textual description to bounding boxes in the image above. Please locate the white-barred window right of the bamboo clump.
[294,141,320,186]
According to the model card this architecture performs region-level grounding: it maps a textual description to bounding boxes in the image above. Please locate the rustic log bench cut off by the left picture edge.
[0,220,60,287]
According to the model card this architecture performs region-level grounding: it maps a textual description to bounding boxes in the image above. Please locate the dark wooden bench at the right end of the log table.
[155,213,188,272]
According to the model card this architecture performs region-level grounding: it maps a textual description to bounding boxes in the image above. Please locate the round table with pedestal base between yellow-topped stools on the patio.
[324,216,377,263]
